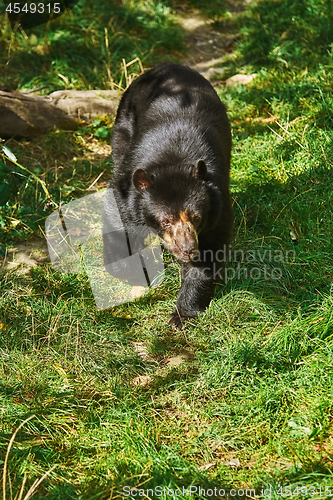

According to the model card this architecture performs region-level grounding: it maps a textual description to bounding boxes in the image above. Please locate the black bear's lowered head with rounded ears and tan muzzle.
[132,160,210,262]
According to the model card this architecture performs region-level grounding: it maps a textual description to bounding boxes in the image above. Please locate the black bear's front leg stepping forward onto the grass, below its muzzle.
[168,262,215,329]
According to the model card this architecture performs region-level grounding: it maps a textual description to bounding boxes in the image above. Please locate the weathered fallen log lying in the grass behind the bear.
[0,90,120,138]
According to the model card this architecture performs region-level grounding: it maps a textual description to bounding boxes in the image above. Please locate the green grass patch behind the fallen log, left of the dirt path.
[0,0,182,93]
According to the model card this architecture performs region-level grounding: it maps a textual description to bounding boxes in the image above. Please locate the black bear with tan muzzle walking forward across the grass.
[103,63,233,328]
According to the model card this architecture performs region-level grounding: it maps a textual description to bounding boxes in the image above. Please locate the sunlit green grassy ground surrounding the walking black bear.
[0,0,333,500]
